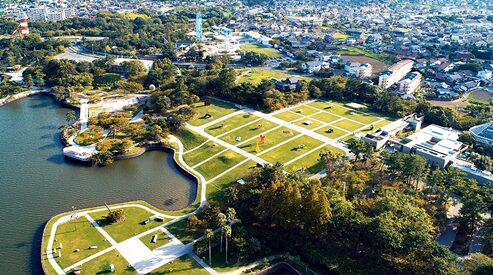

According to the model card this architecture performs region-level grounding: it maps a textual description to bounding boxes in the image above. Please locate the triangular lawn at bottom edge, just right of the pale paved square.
[148,255,209,275]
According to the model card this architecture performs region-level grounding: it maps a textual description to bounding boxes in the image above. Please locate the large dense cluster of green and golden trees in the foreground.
[221,160,468,274]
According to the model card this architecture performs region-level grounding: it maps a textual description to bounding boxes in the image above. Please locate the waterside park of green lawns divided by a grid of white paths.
[42,98,392,274]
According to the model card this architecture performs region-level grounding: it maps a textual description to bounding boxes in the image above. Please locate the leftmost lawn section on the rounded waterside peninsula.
[53,217,110,268]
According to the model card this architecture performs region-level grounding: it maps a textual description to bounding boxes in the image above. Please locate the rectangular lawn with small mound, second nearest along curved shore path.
[195,150,245,180]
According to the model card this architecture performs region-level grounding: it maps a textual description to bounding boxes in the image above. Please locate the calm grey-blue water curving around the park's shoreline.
[0,95,196,274]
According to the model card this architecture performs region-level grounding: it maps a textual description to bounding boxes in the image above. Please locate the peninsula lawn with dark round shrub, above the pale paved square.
[90,207,166,242]
